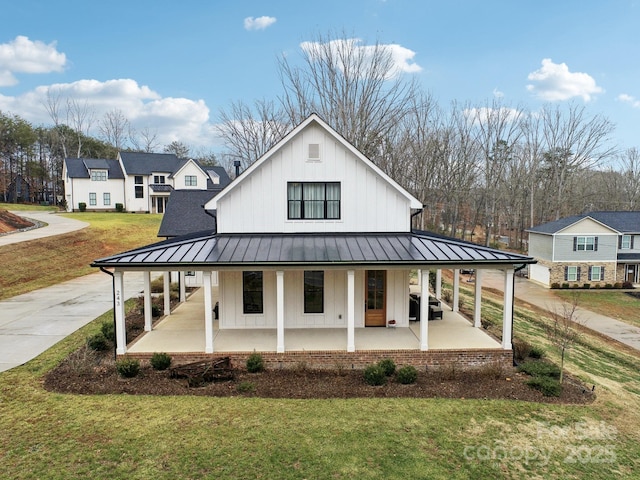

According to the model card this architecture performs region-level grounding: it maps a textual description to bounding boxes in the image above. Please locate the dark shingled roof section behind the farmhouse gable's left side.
[158,189,220,237]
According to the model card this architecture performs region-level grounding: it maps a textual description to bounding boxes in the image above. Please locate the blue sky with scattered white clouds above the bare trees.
[0,0,640,154]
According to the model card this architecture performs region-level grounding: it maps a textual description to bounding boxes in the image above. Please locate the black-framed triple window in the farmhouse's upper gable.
[287,182,340,220]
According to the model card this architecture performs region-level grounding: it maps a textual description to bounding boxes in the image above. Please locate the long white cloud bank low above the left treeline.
[0,79,217,147]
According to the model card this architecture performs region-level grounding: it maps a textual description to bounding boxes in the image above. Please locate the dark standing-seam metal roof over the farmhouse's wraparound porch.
[92,232,535,268]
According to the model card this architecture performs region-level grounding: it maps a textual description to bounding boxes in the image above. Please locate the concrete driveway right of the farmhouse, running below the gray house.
[482,270,640,350]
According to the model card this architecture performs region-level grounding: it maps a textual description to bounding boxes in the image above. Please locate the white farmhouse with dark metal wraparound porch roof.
[93,115,534,365]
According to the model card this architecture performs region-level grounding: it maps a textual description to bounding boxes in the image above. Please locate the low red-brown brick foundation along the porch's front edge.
[118,349,513,370]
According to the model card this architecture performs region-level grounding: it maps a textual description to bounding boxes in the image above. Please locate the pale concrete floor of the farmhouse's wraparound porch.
[127,288,501,353]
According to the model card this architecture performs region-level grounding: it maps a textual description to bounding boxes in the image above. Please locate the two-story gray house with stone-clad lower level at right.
[528,212,640,287]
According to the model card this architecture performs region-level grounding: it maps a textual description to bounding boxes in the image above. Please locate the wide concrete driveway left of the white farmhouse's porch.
[0,272,144,372]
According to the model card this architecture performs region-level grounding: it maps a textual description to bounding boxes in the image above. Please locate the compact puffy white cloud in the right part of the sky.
[527,58,604,102]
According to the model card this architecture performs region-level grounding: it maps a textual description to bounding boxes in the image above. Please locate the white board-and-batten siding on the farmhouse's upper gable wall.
[217,124,411,233]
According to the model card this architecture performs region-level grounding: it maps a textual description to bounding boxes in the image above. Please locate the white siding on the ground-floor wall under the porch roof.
[218,269,409,329]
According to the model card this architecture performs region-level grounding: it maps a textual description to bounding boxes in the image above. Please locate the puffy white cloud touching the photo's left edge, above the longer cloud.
[0,35,67,87]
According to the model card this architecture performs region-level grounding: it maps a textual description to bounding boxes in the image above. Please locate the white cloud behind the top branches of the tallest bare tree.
[300,38,422,76]
